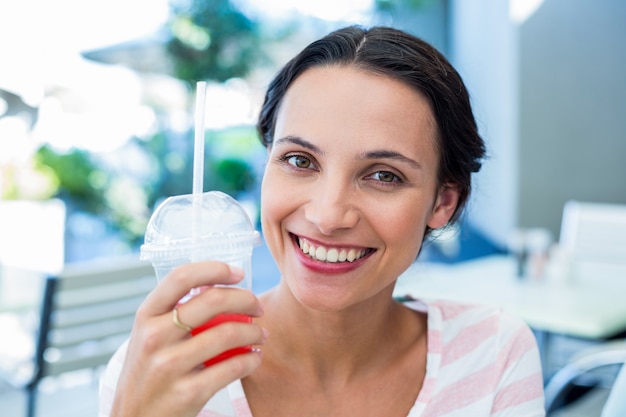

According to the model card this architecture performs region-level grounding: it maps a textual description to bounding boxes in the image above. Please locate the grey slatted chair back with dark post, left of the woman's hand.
[4,258,156,417]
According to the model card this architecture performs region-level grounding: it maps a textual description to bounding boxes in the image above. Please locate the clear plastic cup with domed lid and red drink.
[140,191,260,366]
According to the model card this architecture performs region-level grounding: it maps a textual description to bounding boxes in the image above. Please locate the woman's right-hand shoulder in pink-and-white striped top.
[407,300,543,416]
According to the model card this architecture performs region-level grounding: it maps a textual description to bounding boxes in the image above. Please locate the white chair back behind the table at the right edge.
[559,200,626,278]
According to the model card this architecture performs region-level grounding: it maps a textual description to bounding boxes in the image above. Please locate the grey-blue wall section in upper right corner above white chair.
[519,0,626,236]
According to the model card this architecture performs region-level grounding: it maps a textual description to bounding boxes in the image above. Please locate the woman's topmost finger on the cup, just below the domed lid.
[141,261,243,315]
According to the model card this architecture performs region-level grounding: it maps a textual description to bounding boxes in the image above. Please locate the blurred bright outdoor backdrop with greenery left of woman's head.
[0,0,448,272]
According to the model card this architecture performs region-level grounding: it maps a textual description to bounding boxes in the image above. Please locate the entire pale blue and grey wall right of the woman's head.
[450,0,626,244]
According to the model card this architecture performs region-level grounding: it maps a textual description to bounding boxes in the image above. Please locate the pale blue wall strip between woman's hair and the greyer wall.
[450,0,519,244]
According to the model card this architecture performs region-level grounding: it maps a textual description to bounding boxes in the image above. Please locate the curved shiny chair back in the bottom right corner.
[545,340,626,417]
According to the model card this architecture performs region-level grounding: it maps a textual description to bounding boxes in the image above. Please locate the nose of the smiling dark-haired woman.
[305,181,360,235]
